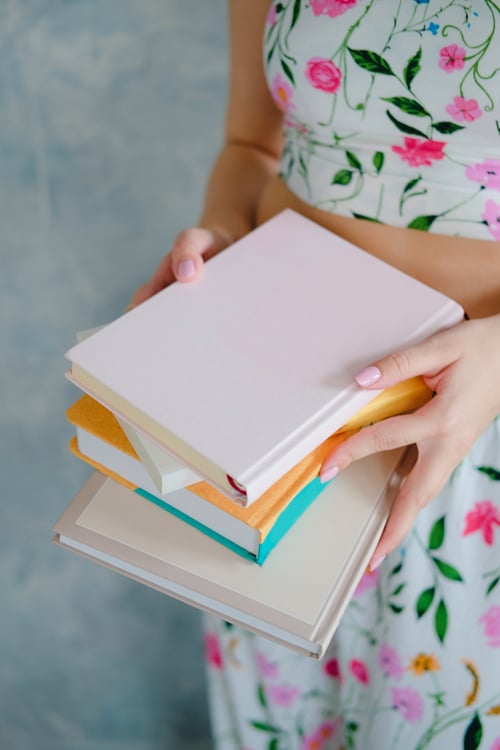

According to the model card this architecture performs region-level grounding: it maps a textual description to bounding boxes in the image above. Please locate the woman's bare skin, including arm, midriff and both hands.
[131,0,500,568]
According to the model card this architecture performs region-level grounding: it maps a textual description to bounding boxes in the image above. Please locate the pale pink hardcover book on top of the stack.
[67,210,463,505]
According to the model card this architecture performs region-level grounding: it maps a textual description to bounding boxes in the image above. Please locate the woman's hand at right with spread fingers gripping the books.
[321,315,500,569]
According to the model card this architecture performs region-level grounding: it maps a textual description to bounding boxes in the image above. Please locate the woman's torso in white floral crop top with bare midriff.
[258,0,500,317]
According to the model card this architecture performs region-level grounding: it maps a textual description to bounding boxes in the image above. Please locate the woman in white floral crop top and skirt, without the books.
[133,0,500,750]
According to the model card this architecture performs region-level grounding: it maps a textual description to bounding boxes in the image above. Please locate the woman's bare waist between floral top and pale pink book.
[257,176,500,317]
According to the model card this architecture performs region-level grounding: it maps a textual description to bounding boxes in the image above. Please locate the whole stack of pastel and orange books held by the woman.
[54,211,463,657]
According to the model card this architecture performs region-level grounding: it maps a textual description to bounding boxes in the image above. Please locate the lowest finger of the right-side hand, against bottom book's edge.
[370,444,455,570]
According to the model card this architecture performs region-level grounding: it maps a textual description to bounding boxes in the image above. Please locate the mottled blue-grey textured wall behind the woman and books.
[0,0,226,750]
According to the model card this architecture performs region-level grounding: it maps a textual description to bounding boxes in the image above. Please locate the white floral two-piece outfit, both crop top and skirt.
[205,0,500,750]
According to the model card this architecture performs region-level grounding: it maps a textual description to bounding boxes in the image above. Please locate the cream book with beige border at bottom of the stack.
[54,450,414,658]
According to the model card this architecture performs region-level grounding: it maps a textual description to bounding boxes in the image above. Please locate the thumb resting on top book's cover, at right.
[354,323,466,389]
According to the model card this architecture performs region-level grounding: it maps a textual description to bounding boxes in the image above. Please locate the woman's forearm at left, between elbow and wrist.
[198,142,278,242]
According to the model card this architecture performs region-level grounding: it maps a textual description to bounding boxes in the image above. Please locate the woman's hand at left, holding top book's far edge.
[128,227,232,310]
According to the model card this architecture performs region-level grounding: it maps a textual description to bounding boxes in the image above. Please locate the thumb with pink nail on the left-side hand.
[170,227,229,282]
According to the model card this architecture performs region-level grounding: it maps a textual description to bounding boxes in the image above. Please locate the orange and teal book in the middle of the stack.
[67,378,431,564]
